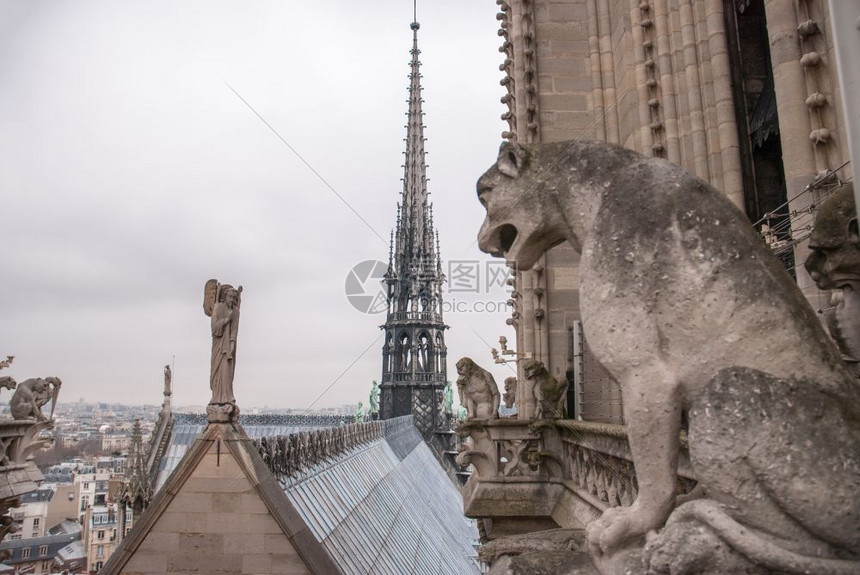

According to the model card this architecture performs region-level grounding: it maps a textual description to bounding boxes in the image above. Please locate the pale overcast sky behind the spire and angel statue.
[0,0,513,408]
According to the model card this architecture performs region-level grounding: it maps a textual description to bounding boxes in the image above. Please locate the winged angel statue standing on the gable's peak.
[203,279,242,421]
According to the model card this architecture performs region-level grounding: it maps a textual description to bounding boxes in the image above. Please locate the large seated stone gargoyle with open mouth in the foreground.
[478,142,860,574]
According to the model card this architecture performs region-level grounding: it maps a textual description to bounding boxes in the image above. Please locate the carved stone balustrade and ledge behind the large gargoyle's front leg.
[457,419,696,529]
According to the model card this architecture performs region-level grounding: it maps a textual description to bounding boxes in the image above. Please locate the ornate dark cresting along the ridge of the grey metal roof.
[254,415,412,481]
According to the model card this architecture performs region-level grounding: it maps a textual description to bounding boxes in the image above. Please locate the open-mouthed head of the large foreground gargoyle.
[478,142,566,270]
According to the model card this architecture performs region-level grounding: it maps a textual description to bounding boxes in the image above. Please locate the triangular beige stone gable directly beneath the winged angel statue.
[100,424,337,575]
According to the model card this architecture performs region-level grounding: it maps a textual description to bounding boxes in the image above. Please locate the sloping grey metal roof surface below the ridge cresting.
[281,425,479,575]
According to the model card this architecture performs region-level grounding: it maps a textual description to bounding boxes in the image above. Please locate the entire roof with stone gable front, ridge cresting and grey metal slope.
[100,417,479,575]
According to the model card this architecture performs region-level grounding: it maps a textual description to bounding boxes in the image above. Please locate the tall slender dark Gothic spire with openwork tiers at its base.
[380,22,448,436]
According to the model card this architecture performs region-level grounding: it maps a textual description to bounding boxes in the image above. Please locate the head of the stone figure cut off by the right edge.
[804,183,860,289]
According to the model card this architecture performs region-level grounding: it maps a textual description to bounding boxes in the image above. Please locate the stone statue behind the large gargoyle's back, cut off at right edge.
[804,182,860,377]
